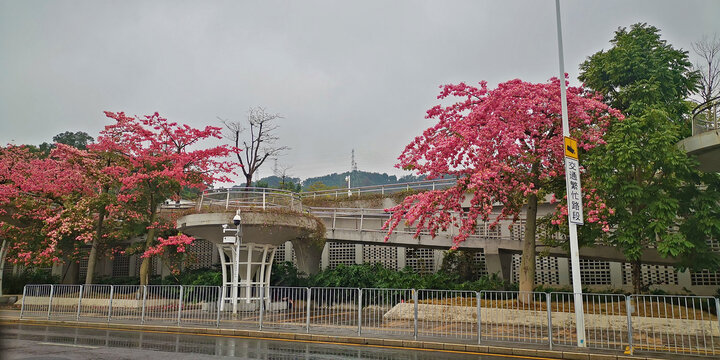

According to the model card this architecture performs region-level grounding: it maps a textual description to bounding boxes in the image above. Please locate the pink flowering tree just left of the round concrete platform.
[89,112,236,285]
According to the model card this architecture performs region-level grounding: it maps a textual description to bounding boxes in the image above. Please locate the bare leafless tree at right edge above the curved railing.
[692,34,720,121]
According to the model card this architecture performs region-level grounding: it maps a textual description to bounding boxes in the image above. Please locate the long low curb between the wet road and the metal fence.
[0,317,661,360]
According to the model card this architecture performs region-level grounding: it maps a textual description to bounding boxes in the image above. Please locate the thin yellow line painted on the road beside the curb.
[0,321,558,360]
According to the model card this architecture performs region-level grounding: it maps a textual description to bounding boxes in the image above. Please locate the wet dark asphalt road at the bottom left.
[0,324,556,360]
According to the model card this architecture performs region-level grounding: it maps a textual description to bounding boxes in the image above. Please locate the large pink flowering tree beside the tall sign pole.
[385,78,622,291]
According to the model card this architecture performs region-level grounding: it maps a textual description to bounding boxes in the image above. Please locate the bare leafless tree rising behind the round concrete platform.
[219,106,289,187]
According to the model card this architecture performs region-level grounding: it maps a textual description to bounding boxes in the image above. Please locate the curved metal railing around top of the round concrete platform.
[196,187,303,212]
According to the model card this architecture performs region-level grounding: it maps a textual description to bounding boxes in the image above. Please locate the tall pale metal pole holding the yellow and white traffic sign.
[555,0,586,347]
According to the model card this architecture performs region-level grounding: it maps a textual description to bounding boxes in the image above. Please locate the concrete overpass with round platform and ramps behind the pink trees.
[178,186,676,279]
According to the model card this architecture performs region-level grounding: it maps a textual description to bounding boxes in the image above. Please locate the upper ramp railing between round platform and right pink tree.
[302,179,457,199]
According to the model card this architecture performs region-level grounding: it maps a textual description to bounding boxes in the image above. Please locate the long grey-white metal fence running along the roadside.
[20,285,720,356]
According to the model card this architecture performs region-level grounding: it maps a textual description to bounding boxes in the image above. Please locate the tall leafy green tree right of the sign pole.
[579,24,720,292]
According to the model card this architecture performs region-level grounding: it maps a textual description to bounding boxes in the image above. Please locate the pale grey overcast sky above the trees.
[0,0,720,183]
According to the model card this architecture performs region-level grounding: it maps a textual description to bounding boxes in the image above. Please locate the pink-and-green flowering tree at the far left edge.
[0,144,95,290]
